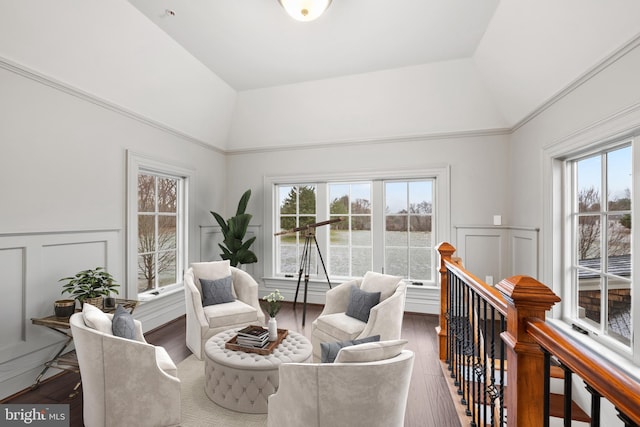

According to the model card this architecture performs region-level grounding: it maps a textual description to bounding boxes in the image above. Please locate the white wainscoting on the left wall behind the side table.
[0,230,124,398]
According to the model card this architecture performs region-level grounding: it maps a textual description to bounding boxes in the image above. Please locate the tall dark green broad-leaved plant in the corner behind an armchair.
[211,190,258,267]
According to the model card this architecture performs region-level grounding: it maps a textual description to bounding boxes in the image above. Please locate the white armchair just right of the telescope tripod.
[311,272,407,362]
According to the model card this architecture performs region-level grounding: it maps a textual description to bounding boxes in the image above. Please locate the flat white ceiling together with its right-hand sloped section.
[129,0,640,126]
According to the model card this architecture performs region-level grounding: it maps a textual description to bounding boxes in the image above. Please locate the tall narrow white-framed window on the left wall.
[127,153,191,299]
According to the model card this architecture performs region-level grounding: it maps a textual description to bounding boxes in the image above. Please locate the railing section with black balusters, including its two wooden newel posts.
[438,243,560,427]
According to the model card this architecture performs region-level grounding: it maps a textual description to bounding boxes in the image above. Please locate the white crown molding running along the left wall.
[0,56,224,154]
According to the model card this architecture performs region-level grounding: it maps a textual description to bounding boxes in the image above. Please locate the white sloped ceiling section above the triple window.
[229,59,506,150]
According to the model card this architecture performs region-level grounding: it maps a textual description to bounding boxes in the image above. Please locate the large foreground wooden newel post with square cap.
[496,276,560,427]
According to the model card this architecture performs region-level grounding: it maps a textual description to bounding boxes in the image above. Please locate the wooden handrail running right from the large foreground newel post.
[526,318,640,425]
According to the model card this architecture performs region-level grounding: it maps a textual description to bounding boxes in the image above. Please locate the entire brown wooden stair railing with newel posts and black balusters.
[438,243,640,427]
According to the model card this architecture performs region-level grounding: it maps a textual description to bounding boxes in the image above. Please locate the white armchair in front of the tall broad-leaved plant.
[184,261,265,359]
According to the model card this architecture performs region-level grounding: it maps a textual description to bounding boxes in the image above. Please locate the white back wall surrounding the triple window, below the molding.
[227,133,510,312]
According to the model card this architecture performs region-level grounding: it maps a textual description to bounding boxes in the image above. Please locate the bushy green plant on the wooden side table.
[59,267,120,308]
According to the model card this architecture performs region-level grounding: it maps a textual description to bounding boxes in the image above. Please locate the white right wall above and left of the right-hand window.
[509,41,640,280]
